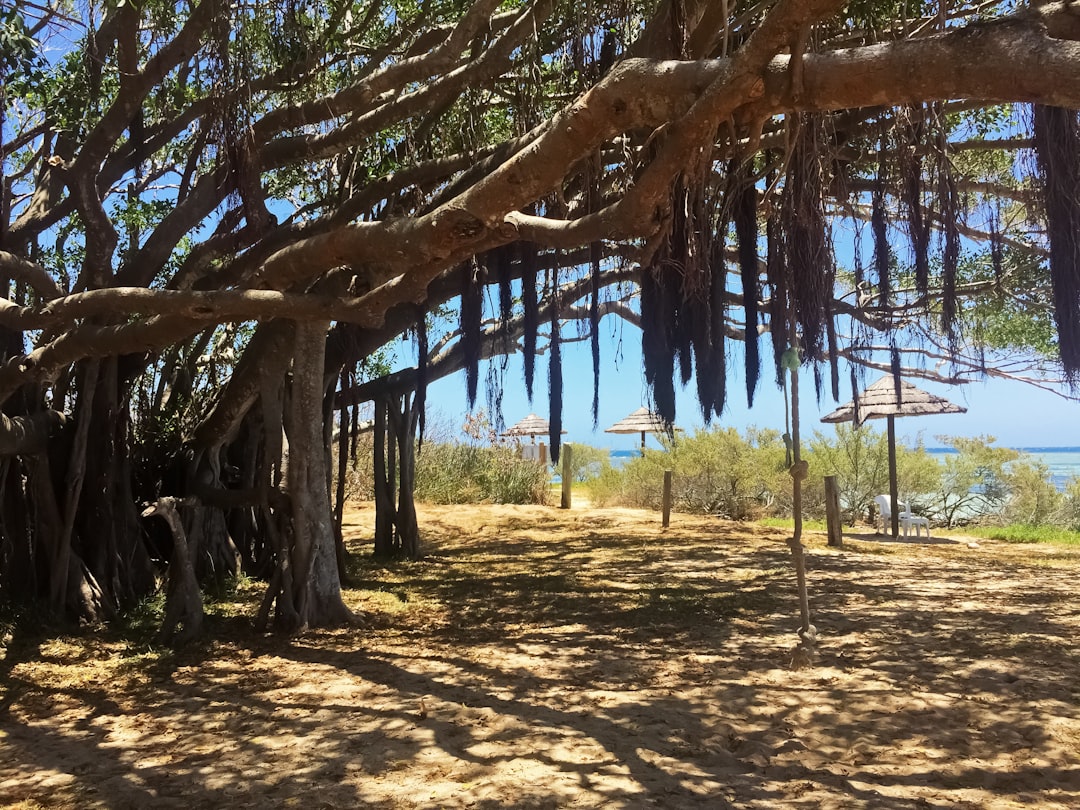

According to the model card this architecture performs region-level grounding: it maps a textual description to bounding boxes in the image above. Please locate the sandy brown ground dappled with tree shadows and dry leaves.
[0,507,1080,810]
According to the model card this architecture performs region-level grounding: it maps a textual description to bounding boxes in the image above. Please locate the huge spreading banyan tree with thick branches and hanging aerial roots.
[0,0,1080,637]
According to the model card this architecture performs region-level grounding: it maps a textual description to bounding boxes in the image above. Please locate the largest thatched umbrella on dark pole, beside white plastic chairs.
[821,375,968,537]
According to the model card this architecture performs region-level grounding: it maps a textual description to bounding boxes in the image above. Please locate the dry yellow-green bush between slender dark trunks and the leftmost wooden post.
[415,442,549,503]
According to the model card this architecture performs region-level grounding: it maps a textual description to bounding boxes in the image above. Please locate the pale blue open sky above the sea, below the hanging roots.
[429,319,1080,449]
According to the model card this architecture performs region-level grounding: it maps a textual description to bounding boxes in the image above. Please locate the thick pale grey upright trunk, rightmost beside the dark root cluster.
[285,322,355,629]
